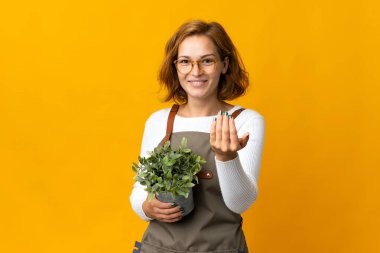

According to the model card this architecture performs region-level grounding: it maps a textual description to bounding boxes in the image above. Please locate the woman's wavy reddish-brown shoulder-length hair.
[158,20,249,103]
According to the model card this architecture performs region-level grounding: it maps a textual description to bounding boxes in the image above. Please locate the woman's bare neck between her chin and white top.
[178,98,233,117]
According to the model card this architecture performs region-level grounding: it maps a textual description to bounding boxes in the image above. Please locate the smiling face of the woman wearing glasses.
[177,35,228,101]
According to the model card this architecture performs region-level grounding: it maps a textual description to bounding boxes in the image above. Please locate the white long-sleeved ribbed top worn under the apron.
[130,105,264,221]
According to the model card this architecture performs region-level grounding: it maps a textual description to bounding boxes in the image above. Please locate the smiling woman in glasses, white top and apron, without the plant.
[130,20,264,253]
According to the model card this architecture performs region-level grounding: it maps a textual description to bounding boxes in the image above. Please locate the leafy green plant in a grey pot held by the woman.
[132,137,206,216]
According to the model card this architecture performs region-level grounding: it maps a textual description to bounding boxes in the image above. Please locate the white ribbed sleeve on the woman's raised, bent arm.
[215,116,264,213]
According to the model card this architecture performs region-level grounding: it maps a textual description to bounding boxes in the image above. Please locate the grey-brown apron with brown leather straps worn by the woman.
[140,105,248,253]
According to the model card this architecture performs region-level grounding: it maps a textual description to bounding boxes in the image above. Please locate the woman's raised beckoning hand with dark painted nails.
[210,113,249,162]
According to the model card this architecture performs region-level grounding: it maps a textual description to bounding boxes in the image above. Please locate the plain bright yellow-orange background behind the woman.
[0,0,380,253]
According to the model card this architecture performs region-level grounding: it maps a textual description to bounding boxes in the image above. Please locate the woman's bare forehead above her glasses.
[178,35,217,57]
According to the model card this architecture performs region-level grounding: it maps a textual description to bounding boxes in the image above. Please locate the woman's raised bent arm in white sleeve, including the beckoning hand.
[211,112,264,213]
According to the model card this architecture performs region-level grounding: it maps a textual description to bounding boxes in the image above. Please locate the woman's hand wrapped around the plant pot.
[142,196,182,222]
